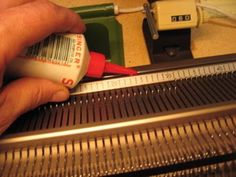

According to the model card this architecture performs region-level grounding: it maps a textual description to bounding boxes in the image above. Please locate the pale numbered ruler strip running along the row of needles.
[71,62,236,95]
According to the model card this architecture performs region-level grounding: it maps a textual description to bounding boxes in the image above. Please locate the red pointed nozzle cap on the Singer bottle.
[86,52,137,78]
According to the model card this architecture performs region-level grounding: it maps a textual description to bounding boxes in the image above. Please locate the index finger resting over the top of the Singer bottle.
[0,1,85,63]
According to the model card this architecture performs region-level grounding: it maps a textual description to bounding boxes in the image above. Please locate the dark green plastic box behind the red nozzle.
[72,3,124,65]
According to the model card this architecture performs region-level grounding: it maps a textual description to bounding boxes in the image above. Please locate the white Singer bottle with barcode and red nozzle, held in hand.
[7,34,137,88]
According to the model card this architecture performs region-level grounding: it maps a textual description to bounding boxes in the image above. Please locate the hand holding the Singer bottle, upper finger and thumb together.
[0,0,85,134]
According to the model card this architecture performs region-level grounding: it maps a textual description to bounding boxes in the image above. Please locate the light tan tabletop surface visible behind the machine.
[51,0,236,66]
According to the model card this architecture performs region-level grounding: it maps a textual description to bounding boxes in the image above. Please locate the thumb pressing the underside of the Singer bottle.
[0,78,69,133]
